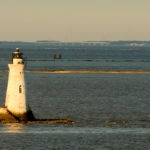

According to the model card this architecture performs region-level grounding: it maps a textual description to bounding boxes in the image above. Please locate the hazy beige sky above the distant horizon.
[0,0,150,42]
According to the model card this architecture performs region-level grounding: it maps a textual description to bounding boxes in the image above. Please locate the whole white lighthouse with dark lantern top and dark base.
[5,48,35,120]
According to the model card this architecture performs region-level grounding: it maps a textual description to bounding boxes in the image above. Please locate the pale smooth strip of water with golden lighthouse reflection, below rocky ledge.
[0,124,150,135]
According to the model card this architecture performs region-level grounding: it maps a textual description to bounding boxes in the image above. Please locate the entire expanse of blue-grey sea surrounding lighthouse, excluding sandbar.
[0,43,150,150]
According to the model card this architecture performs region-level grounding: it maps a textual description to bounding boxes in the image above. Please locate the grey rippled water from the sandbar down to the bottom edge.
[0,72,150,150]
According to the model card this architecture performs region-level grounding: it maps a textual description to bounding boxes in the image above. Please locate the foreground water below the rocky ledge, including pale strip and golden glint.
[0,125,149,150]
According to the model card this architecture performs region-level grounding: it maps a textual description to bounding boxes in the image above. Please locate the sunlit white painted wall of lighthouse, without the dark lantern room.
[5,59,29,115]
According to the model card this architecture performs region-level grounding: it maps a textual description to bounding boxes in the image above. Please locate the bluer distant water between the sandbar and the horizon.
[0,42,150,70]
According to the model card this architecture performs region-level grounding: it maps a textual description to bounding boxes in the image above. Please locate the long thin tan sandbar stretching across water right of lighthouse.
[30,70,150,74]
